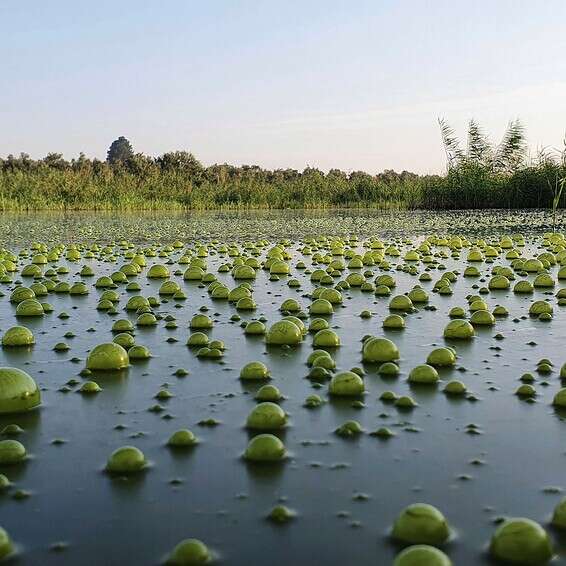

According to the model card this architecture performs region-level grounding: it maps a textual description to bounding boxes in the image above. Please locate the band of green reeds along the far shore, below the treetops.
[0,165,566,211]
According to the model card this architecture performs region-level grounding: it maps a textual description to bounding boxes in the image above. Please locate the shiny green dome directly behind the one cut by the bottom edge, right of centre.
[391,503,450,546]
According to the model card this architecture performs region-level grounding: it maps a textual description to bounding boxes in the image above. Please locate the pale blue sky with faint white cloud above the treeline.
[0,0,566,173]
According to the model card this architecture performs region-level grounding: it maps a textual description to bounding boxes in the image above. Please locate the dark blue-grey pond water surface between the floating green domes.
[0,212,566,566]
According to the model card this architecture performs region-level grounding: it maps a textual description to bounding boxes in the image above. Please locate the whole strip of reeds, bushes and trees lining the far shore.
[0,121,566,210]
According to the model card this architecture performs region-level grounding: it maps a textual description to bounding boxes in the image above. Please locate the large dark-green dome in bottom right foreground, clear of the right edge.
[489,518,553,566]
